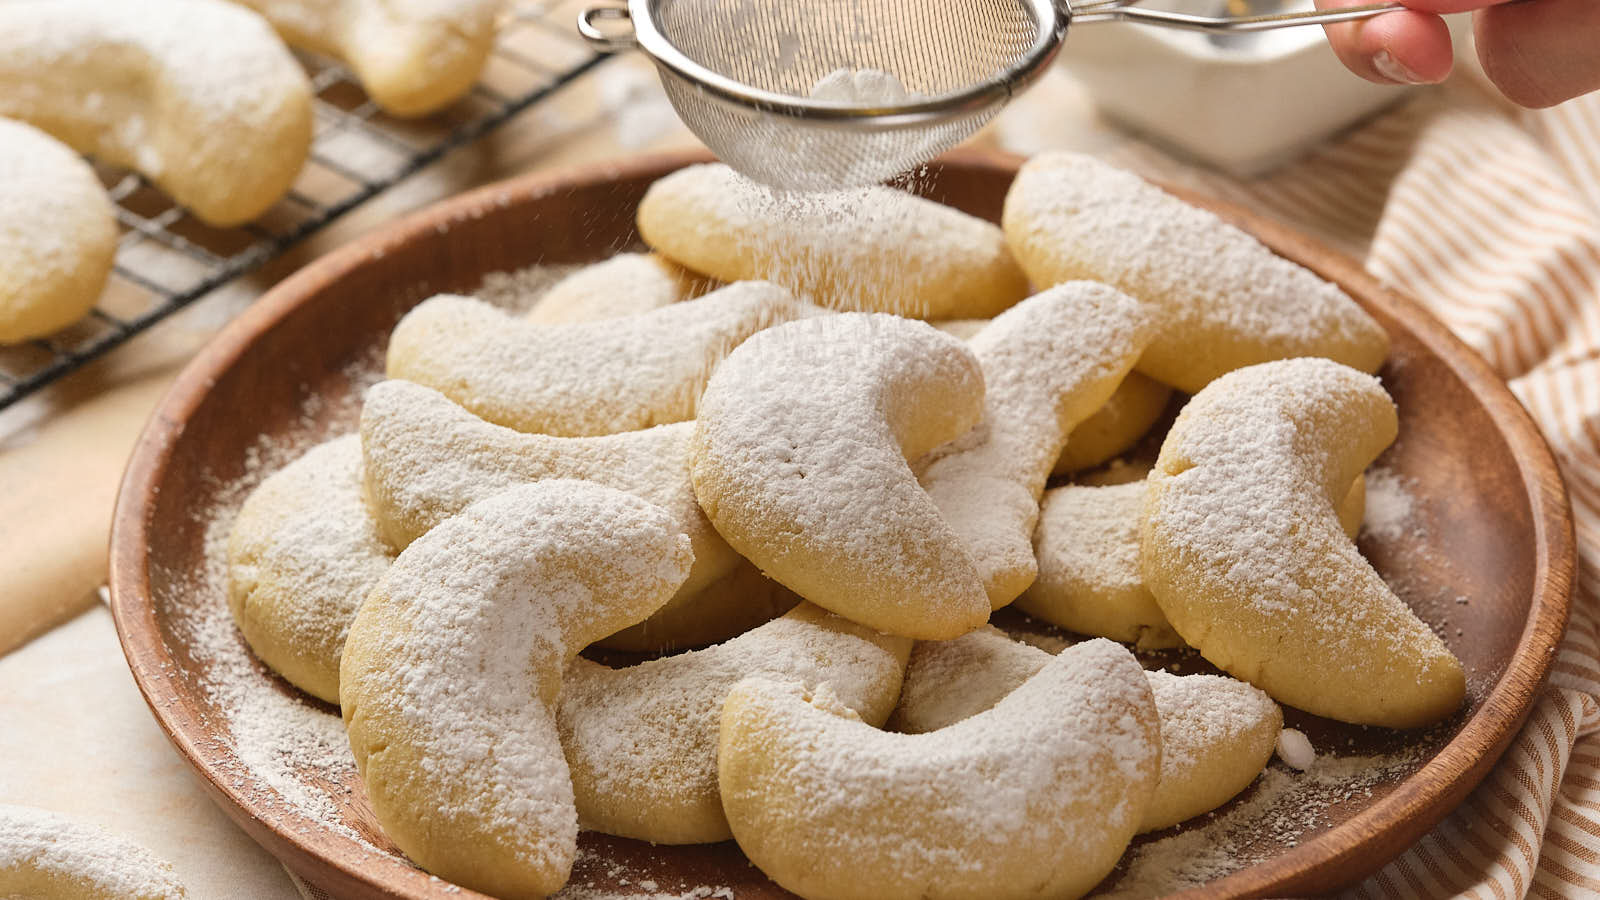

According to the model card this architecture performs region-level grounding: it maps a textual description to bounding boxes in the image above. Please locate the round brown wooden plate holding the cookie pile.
[110,154,1574,898]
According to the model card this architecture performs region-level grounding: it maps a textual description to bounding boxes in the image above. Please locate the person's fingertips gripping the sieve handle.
[1317,0,1600,107]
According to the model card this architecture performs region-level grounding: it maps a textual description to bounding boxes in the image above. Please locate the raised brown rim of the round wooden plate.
[109,149,1576,900]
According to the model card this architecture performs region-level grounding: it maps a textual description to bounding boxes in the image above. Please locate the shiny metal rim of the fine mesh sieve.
[627,0,1072,131]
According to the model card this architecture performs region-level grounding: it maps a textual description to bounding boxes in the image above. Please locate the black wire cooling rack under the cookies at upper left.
[0,0,605,410]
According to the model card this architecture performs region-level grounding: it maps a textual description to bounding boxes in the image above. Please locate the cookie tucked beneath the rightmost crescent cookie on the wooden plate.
[1016,476,1366,650]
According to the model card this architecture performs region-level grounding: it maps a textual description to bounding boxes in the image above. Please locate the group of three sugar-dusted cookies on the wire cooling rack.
[0,0,501,343]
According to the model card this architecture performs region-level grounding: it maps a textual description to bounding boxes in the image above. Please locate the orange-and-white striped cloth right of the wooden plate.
[1114,78,1600,900]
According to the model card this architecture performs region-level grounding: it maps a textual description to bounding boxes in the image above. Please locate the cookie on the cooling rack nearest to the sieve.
[234,0,504,117]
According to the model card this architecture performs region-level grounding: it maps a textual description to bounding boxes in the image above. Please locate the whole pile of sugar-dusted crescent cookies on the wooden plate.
[229,154,1464,898]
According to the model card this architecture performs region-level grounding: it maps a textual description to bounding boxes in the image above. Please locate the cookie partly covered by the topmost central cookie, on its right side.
[922,282,1155,609]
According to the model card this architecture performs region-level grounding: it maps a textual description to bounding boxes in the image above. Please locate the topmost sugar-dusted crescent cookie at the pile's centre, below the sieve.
[690,312,989,637]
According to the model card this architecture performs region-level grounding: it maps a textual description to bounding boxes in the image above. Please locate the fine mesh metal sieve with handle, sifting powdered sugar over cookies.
[578,0,1403,191]
